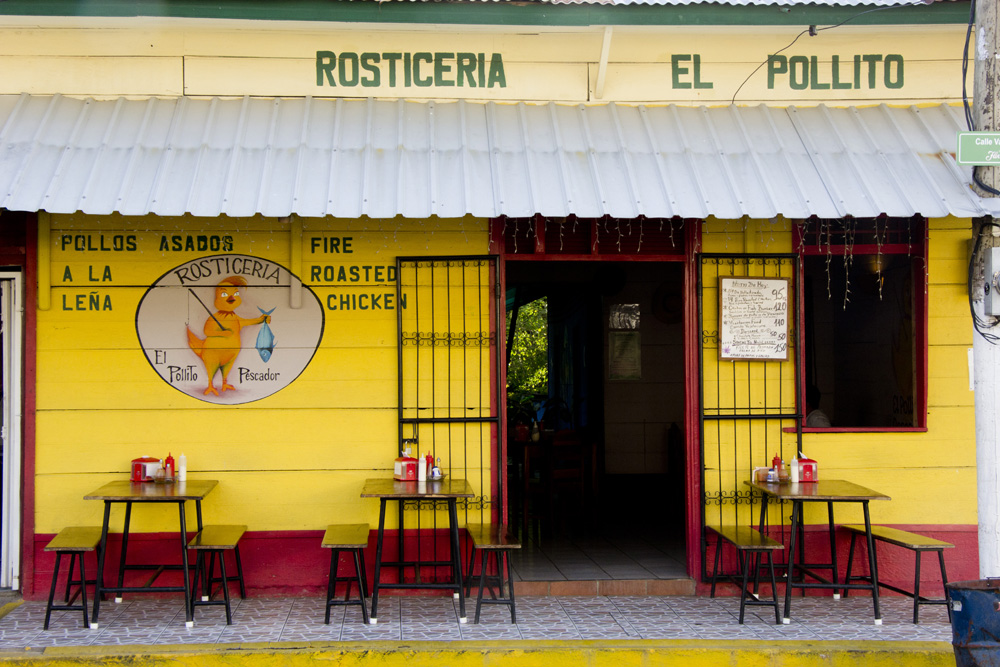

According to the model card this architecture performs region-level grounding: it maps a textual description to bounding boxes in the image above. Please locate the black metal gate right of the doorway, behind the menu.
[698,254,803,577]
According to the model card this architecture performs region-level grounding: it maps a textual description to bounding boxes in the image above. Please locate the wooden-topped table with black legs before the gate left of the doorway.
[361,477,475,625]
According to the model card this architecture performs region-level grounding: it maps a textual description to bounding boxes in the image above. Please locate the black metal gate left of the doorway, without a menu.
[396,256,504,527]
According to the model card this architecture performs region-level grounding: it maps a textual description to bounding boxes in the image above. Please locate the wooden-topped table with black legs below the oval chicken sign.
[84,479,218,629]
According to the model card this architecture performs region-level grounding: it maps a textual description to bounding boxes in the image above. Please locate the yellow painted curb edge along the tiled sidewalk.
[0,639,955,667]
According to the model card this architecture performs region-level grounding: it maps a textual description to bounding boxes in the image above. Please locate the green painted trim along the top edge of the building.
[0,0,969,26]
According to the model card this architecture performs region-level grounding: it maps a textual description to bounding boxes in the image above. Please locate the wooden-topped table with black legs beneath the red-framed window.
[747,479,889,625]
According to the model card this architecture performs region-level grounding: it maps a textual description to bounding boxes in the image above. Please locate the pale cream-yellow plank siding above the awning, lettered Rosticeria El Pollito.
[0,22,971,105]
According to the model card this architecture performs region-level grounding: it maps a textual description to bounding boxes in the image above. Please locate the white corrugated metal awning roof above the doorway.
[0,95,990,219]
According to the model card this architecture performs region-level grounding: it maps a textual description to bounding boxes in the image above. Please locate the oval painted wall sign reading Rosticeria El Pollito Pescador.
[135,255,324,405]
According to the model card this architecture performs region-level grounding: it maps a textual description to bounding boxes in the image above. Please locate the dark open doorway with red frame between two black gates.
[505,261,688,581]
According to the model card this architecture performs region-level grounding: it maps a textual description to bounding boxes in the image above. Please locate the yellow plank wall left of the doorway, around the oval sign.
[30,214,490,533]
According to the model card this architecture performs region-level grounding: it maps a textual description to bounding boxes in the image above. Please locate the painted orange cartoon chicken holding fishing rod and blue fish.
[187,276,274,396]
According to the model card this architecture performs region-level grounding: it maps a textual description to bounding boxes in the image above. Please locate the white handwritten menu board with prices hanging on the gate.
[719,278,788,361]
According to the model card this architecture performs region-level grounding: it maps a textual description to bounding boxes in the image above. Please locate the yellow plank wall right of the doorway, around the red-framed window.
[702,218,977,525]
